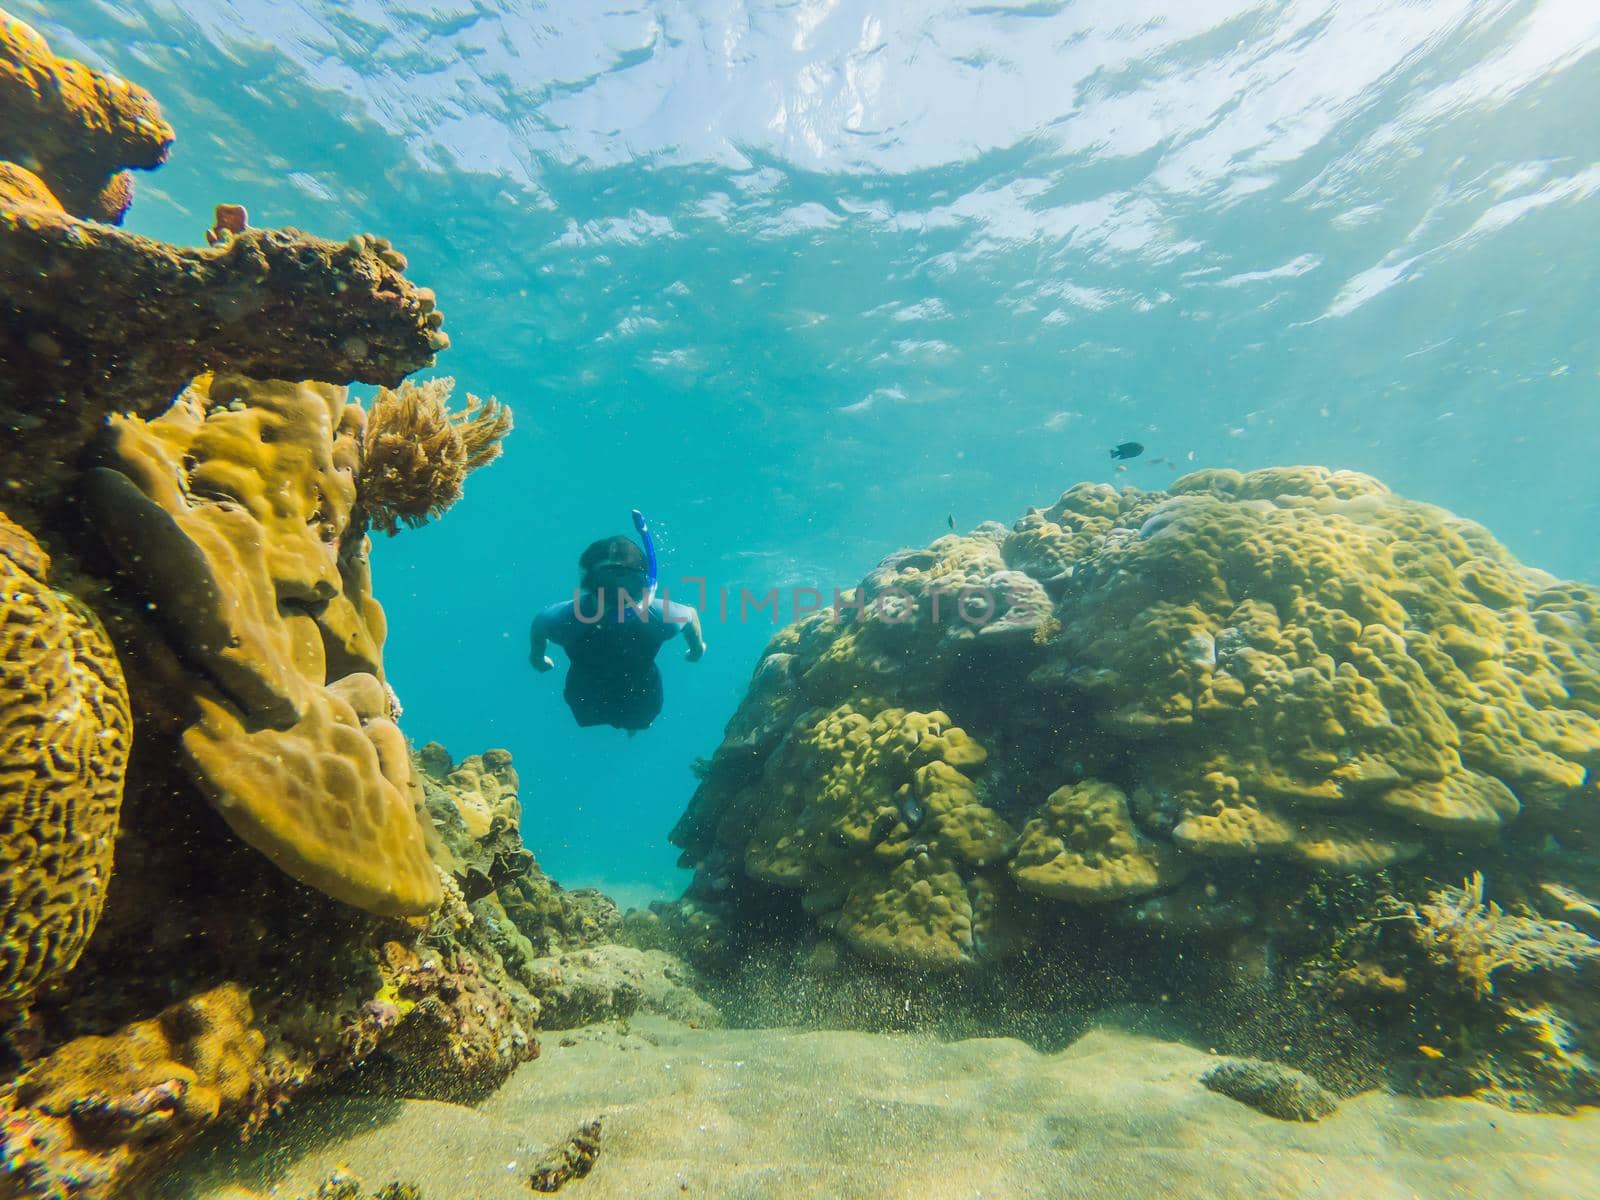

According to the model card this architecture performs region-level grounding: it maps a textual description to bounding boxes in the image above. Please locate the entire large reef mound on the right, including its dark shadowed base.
[665,467,1600,1107]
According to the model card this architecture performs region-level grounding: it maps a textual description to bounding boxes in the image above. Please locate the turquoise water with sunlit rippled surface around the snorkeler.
[28,0,1600,899]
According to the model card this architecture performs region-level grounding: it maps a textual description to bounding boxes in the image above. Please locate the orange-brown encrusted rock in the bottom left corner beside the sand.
[0,984,266,1200]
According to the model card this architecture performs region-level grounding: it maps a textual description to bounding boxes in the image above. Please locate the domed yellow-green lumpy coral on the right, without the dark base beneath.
[674,467,1600,963]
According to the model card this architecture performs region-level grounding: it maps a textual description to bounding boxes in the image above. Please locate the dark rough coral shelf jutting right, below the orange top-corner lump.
[0,200,448,505]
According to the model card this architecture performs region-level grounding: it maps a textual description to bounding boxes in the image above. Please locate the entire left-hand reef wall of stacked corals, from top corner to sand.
[0,13,688,1200]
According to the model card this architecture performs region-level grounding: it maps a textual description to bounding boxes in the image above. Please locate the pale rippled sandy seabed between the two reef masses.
[158,1018,1600,1200]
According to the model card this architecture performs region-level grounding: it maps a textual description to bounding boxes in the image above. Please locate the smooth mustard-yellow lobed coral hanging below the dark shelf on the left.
[86,376,440,915]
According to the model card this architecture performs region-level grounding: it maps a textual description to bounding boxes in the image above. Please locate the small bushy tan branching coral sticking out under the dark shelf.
[355,376,512,534]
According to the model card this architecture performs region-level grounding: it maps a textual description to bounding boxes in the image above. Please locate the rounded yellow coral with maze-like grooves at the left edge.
[0,514,133,1002]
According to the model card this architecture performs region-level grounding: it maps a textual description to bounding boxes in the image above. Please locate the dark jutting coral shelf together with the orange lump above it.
[0,11,450,507]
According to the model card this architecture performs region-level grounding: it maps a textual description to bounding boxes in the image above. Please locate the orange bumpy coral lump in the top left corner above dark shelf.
[0,11,174,224]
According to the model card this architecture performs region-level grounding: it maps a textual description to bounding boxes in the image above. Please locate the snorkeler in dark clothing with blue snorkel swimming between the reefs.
[528,509,706,734]
